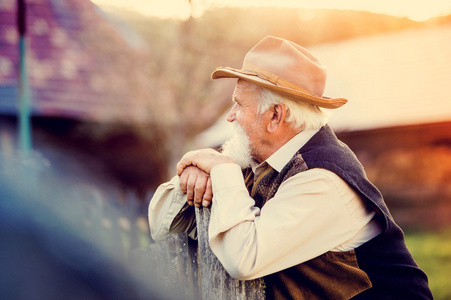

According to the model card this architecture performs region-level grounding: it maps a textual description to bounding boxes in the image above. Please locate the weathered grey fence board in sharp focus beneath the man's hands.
[196,207,264,300]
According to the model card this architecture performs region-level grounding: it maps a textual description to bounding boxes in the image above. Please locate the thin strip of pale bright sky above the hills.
[91,0,451,21]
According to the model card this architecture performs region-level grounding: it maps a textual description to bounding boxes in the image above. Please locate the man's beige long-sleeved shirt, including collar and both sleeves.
[149,132,381,280]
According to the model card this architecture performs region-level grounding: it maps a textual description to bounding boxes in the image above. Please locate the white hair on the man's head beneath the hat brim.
[252,84,330,131]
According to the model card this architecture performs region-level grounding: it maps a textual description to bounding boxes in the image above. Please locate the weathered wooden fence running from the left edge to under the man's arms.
[0,152,264,300]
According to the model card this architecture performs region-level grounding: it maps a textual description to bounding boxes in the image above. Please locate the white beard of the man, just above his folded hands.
[221,121,254,169]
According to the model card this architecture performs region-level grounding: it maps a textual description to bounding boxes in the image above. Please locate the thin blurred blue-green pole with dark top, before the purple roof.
[17,0,32,158]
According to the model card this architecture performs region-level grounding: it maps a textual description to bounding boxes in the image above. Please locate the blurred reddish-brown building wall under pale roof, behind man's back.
[338,122,451,229]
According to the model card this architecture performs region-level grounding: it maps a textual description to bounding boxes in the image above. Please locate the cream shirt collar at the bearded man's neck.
[266,130,318,172]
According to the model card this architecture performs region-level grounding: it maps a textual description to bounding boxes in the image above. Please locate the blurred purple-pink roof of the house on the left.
[0,0,150,121]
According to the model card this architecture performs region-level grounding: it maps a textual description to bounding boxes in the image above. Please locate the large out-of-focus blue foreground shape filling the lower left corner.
[0,161,184,299]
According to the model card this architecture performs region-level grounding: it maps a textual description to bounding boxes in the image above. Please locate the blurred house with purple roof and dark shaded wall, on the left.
[0,0,166,195]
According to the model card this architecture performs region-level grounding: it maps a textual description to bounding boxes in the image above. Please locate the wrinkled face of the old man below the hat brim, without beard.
[227,80,267,162]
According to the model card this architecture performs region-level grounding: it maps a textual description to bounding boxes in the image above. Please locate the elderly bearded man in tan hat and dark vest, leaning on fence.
[149,37,432,299]
